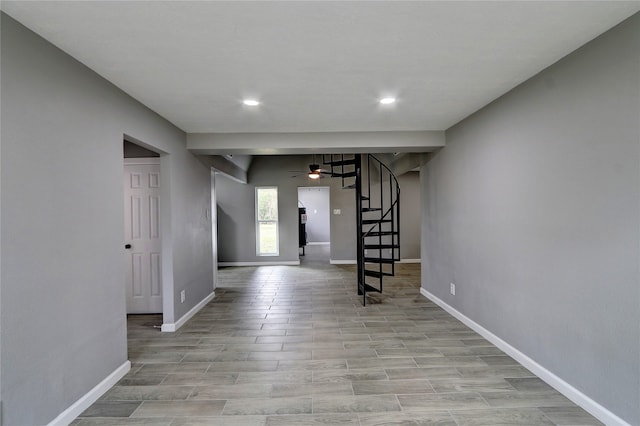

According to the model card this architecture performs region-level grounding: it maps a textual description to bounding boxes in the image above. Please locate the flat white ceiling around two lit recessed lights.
[2,1,640,133]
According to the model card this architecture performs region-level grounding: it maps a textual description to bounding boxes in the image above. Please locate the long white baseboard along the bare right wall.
[420,288,631,426]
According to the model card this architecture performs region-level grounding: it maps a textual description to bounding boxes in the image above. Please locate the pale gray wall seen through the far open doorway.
[298,187,331,243]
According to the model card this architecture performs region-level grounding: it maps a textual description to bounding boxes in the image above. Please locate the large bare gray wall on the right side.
[422,15,640,425]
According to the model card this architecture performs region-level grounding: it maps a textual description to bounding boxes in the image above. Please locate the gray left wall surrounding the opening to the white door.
[0,14,213,425]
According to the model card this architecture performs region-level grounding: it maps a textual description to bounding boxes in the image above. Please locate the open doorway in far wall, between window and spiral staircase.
[298,186,331,264]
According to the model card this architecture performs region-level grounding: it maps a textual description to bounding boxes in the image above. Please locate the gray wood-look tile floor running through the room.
[73,262,601,426]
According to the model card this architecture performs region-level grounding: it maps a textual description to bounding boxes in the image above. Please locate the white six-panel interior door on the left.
[124,158,162,314]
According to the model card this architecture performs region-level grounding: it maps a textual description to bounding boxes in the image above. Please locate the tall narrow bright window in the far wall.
[256,186,279,256]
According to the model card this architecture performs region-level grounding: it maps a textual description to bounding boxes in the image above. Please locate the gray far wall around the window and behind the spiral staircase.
[216,155,420,262]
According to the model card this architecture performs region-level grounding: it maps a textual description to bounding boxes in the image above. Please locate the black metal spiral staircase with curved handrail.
[322,154,400,306]
